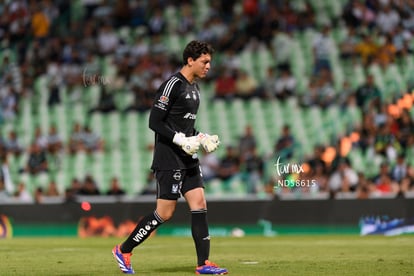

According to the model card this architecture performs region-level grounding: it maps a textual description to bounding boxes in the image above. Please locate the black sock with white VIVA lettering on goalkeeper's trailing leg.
[121,211,164,253]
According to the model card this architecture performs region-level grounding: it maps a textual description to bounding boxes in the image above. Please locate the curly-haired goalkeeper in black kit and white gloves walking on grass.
[112,41,227,275]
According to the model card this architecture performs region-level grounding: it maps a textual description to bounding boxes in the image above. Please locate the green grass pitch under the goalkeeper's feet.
[0,235,414,276]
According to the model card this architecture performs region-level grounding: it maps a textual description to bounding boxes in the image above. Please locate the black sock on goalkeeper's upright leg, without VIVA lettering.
[191,209,210,266]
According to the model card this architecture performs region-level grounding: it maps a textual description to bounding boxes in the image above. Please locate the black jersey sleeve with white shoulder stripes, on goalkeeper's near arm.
[149,78,181,141]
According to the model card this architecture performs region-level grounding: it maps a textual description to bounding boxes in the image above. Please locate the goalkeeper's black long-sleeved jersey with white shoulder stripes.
[149,72,200,170]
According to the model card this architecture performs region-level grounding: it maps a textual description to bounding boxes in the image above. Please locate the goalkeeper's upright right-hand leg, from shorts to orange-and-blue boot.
[182,168,228,275]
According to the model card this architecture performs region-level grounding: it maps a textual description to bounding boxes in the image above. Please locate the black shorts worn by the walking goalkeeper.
[154,166,204,200]
